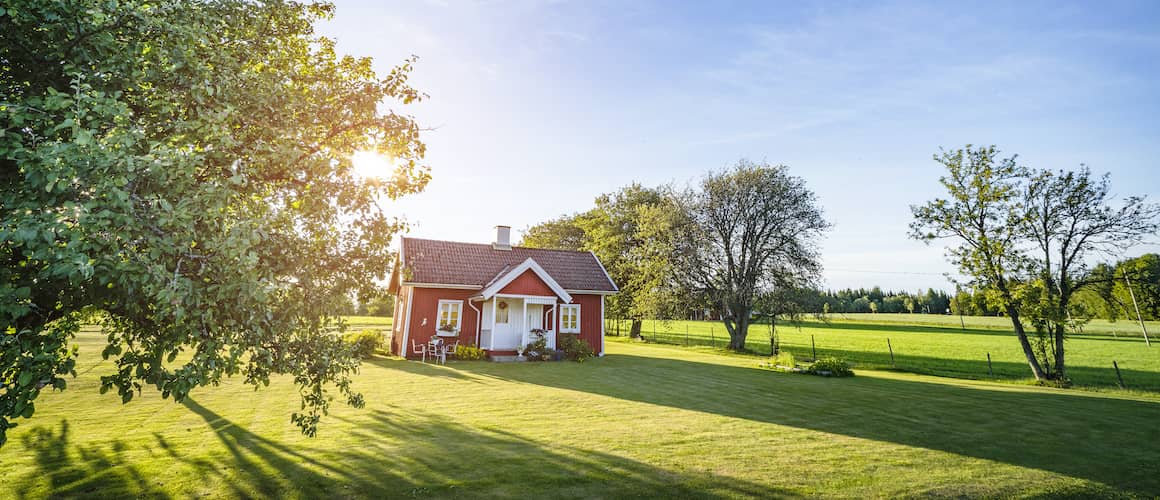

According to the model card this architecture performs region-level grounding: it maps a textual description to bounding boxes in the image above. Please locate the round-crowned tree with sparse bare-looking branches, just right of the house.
[673,160,829,350]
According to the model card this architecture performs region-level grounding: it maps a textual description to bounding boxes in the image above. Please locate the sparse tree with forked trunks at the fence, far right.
[911,145,1160,383]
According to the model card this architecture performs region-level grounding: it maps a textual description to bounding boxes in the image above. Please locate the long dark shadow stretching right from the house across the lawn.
[450,355,1160,495]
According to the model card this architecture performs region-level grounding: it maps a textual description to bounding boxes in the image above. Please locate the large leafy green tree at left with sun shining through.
[0,0,428,442]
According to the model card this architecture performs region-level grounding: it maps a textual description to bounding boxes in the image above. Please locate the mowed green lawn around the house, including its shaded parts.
[0,331,1160,498]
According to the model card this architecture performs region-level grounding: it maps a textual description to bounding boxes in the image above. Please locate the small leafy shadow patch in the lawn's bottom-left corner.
[11,420,169,499]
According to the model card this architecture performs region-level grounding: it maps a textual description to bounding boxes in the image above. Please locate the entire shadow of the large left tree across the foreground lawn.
[14,399,795,499]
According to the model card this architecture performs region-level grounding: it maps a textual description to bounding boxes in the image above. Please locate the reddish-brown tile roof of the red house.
[403,238,617,291]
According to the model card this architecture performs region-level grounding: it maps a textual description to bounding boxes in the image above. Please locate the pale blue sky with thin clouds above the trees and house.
[319,0,1160,289]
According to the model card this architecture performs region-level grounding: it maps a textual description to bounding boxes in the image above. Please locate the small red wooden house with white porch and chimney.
[390,226,617,357]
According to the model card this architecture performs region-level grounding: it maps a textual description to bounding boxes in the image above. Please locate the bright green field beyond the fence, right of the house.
[626,314,1160,391]
